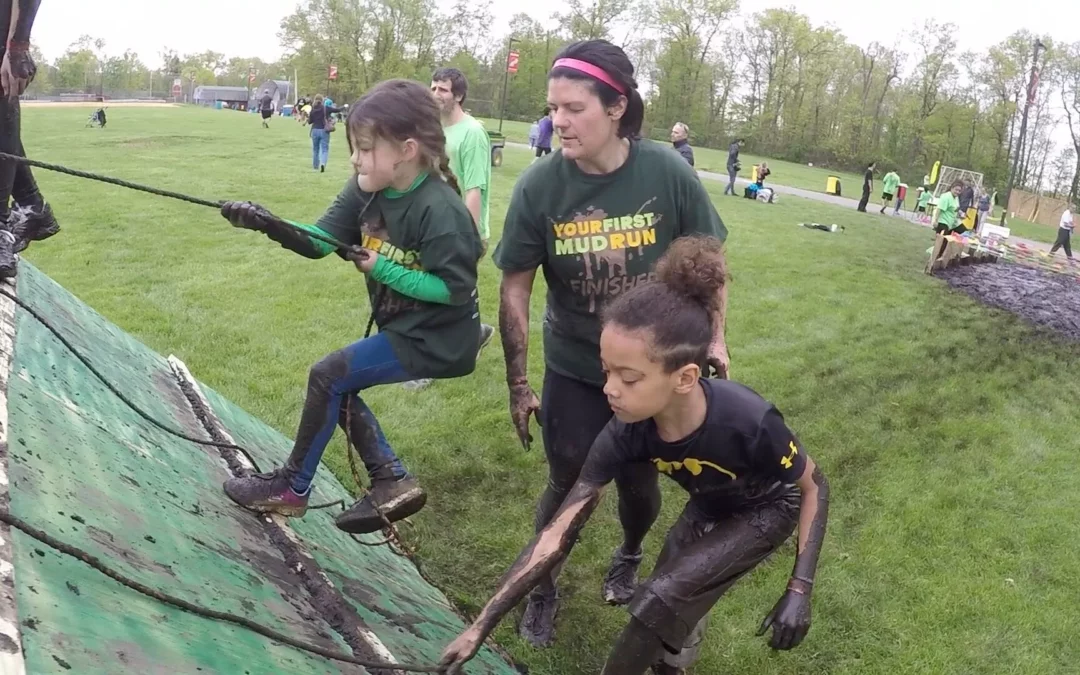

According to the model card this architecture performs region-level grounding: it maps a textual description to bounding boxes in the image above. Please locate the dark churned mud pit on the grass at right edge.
[937,262,1080,342]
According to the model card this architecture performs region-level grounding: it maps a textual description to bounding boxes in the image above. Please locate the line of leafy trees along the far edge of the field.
[25,0,1080,199]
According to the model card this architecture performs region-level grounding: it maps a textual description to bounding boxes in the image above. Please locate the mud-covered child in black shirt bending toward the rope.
[442,237,829,675]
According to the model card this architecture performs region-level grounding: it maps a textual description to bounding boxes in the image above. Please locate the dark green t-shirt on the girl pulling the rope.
[316,175,481,378]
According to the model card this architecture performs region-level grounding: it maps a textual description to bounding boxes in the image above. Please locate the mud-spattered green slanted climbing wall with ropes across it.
[3,261,516,675]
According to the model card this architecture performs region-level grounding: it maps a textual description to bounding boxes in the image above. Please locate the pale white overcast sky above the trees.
[33,0,1080,66]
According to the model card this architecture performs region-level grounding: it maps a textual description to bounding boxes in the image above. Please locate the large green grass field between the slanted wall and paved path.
[23,107,1080,675]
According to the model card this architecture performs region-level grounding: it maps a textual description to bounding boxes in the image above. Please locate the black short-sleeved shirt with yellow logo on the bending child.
[581,379,806,518]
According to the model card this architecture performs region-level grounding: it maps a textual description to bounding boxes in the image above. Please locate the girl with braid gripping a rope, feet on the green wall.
[213,80,481,534]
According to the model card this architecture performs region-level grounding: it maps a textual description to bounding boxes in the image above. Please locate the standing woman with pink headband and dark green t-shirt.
[495,40,728,646]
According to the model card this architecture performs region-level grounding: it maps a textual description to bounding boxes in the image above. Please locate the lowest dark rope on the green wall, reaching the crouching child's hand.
[0,511,444,673]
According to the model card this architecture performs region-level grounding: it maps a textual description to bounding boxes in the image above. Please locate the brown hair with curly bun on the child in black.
[604,235,728,373]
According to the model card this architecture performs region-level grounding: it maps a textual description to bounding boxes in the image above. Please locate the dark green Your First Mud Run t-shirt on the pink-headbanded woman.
[495,140,727,386]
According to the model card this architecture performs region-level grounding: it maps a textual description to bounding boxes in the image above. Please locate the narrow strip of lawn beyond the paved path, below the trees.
[481,118,864,192]
